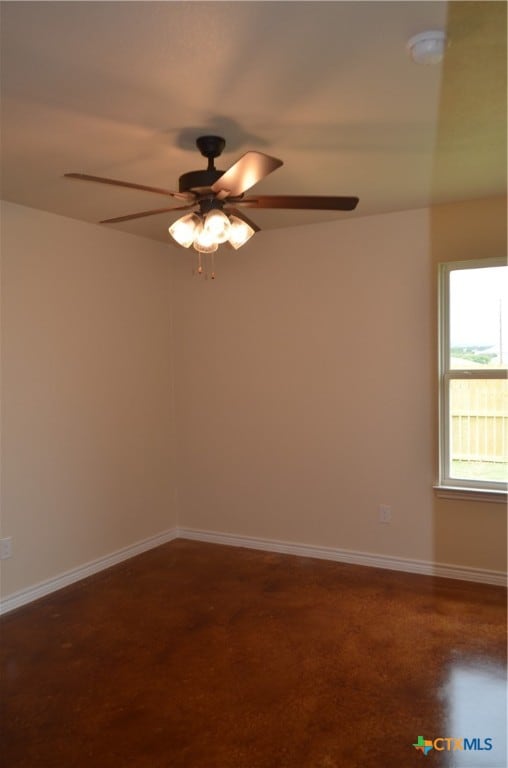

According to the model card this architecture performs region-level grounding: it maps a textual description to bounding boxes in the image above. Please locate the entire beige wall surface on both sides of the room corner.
[1,195,506,596]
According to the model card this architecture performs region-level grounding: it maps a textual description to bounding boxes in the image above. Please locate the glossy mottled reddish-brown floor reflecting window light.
[0,540,506,768]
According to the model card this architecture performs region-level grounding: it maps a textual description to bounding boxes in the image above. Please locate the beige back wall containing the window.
[175,202,506,571]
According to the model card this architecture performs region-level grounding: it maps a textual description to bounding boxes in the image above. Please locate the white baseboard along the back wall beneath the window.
[178,528,507,587]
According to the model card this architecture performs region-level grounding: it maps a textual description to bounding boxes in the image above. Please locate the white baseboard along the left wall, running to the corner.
[0,528,178,615]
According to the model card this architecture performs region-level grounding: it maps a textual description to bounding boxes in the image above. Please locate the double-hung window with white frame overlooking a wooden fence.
[439,259,508,492]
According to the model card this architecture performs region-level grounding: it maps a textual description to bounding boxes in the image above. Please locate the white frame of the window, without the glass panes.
[436,257,508,499]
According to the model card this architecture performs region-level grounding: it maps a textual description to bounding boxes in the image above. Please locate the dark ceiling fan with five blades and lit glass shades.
[64,136,358,271]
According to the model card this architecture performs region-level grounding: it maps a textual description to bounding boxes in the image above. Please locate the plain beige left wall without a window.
[1,203,176,595]
